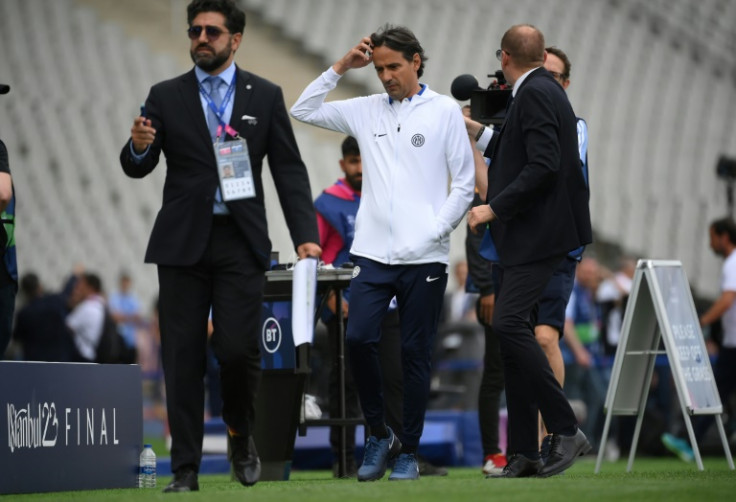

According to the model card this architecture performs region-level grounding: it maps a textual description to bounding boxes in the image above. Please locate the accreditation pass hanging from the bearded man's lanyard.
[214,138,256,201]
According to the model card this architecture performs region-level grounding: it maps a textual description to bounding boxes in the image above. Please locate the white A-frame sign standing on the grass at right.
[595,260,734,473]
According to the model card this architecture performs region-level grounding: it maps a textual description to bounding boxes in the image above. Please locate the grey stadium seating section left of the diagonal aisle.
[0,0,339,305]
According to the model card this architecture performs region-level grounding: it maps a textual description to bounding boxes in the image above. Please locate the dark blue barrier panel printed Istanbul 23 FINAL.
[0,361,143,494]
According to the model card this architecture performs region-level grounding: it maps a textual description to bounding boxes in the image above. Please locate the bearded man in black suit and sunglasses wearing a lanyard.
[120,0,321,491]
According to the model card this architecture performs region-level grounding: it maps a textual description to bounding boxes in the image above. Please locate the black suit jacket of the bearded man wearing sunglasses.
[120,69,319,270]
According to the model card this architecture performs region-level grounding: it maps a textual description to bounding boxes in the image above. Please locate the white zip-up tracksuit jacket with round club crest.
[291,68,475,265]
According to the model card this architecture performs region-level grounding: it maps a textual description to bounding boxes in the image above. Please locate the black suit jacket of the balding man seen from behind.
[485,68,592,266]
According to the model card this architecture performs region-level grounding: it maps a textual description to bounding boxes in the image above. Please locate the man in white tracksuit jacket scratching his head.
[291,26,475,481]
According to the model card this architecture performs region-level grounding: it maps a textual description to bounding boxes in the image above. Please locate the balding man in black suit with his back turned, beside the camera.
[468,25,592,477]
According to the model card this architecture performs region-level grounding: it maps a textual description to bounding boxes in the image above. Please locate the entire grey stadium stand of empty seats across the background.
[0,0,736,310]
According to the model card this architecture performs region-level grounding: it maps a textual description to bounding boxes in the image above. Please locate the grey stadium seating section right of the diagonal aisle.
[237,0,736,295]
